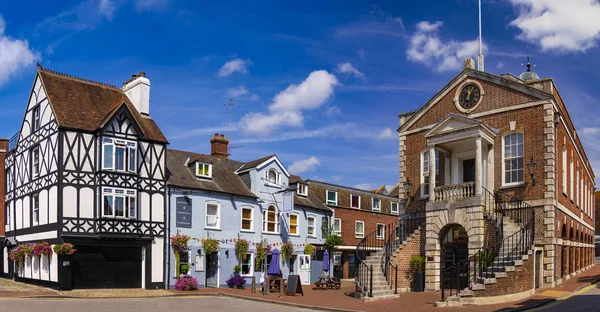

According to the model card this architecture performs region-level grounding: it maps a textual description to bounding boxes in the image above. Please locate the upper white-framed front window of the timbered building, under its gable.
[102,138,137,173]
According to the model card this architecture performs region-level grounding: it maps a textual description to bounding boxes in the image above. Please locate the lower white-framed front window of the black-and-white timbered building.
[102,187,137,219]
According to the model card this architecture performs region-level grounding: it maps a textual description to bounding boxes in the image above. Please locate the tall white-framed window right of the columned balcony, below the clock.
[502,132,524,185]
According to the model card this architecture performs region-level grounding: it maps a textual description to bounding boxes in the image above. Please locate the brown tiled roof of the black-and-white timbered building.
[38,67,167,143]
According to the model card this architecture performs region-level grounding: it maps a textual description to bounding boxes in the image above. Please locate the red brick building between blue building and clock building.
[306,180,399,279]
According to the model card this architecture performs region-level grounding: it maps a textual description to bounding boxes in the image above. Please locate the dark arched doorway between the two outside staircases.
[440,224,469,289]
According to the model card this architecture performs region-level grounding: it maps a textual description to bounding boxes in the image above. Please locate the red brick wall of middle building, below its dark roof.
[334,208,398,246]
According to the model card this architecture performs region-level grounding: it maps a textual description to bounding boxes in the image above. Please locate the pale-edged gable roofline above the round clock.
[398,68,553,131]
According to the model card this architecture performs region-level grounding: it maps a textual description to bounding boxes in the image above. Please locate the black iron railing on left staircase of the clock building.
[355,214,425,297]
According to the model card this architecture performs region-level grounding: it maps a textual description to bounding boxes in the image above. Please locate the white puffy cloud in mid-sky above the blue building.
[240,70,338,135]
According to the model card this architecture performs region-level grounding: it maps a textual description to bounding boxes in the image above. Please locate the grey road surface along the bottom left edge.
[0,297,309,312]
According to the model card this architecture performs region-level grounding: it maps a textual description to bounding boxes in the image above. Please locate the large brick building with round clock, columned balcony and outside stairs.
[358,59,595,300]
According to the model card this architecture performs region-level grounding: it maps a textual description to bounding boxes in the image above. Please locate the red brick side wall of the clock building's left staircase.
[388,229,425,289]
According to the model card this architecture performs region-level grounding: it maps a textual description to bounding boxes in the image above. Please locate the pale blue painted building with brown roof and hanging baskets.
[165,135,333,288]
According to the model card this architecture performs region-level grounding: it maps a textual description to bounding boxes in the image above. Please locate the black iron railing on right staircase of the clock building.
[440,192,535,301]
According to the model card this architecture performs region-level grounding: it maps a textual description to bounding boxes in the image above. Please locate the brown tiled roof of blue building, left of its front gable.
[167,149,256,197]
